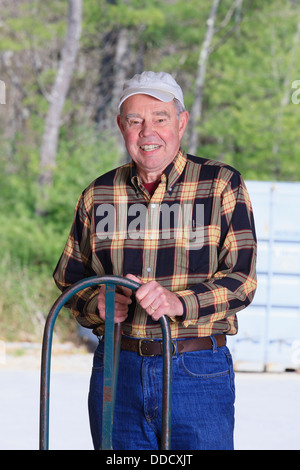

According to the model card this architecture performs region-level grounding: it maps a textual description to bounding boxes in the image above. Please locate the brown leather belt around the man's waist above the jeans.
[121,334,226,356]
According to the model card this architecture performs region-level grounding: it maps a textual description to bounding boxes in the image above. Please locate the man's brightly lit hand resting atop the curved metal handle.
[126,274,183,321]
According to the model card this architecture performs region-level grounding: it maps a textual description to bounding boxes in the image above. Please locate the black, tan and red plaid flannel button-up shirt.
[54,149,256,338]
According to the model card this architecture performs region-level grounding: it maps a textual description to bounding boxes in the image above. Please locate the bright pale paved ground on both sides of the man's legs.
[0,342,300,450]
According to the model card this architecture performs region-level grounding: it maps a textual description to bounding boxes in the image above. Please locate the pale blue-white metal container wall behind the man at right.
[228,181,300,371]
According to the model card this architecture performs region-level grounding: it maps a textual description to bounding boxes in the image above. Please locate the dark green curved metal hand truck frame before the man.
[39,276,172,450]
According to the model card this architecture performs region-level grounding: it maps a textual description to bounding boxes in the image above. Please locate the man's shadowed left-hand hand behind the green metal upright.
[98,276,132,323]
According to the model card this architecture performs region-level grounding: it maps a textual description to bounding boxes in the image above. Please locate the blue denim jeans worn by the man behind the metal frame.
[89,339,235,450]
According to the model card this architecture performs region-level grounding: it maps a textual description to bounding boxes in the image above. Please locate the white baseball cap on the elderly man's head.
[119,72,184,108]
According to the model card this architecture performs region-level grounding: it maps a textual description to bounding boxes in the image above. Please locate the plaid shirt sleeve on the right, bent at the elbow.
[176,173,257,327]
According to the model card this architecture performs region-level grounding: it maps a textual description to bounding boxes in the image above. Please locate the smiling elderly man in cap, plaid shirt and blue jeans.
[54,72,256,450]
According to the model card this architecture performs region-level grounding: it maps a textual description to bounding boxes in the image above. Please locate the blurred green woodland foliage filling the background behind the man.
[0,0,300,338]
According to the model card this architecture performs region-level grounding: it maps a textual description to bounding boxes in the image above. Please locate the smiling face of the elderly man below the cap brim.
[118,94,188,182]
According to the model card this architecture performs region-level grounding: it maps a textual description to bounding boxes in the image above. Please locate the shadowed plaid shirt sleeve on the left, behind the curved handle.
[53,194,104,334]
